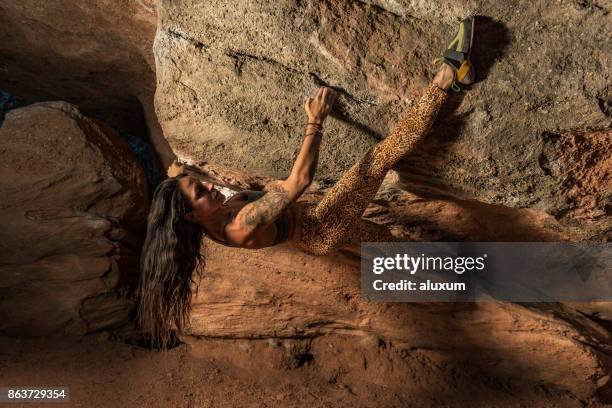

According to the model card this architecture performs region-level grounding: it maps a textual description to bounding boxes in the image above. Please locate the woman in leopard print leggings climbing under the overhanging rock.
[138,18,474,347]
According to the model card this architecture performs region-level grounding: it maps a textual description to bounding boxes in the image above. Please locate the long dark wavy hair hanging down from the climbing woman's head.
[137,173,205,349]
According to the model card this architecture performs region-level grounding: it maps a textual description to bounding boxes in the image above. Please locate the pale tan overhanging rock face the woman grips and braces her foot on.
[154,0,612,237]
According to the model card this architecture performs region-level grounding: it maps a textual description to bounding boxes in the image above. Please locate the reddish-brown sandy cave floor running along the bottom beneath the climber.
[0,332,603,408]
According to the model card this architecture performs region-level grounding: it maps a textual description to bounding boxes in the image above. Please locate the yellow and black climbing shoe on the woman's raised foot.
[434,17,476,92]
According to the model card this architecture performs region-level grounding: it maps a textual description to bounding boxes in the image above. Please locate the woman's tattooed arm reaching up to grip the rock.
[225,87,336,243]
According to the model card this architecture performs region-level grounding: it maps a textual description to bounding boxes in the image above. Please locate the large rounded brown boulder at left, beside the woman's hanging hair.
[0,102,148,335]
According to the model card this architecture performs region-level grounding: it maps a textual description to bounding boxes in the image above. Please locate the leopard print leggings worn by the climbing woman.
[297,84,448,255]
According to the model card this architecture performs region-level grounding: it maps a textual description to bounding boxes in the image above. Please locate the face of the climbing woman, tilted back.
[178,176,225,222]
